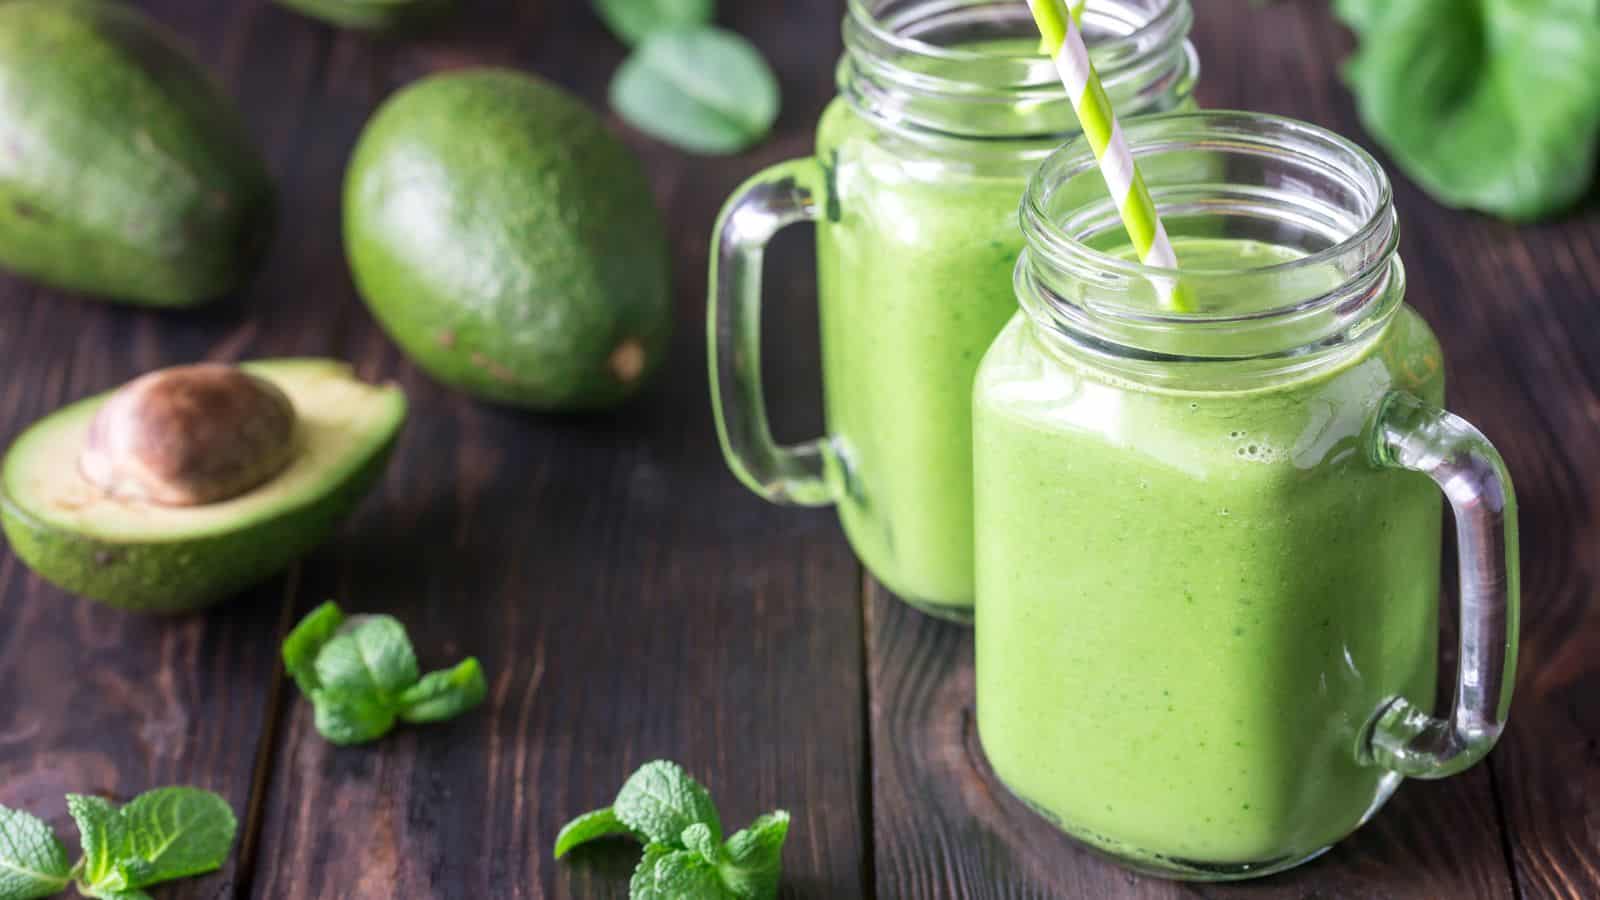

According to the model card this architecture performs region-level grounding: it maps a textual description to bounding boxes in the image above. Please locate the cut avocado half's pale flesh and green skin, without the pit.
[0,359,406,613]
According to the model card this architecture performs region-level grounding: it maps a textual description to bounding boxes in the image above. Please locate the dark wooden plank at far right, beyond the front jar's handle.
[1438,197,1600,898]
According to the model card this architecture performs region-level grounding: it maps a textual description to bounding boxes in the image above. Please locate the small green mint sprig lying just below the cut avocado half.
[283,602,488,745]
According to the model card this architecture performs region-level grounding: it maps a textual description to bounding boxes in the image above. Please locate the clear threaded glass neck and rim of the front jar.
[1016,110,1405,378]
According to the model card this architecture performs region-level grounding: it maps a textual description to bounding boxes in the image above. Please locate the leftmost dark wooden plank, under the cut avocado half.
[0,0,330,898]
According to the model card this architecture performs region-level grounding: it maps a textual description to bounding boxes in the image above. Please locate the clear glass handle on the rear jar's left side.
[706,159,837,506]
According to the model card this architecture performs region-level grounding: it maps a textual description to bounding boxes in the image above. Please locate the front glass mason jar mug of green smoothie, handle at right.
[973,112,1518,879]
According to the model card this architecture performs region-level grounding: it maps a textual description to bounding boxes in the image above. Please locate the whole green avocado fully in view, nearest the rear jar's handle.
[344,69,672,410]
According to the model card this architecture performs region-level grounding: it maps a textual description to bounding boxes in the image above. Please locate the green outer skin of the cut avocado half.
[0,439,394,615]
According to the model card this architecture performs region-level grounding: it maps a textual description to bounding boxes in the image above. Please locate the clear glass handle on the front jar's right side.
[1363,394,1520,778]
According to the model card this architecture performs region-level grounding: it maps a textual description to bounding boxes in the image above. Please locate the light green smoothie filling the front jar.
[974,239,1443,870]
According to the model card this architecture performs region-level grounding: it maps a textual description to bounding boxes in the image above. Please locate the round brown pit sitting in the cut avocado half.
[78,364,296,506]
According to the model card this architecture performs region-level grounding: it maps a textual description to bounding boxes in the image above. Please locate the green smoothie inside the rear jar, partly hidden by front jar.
[818,101,1032,617]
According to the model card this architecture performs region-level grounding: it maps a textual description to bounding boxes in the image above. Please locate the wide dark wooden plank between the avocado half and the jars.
[250,0,866,900]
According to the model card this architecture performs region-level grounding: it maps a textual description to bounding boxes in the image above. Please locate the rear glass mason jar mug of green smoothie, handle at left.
[707,0,1197,620]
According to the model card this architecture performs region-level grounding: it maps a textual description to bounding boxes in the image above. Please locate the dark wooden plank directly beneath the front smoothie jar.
[867,0,1514,898]
